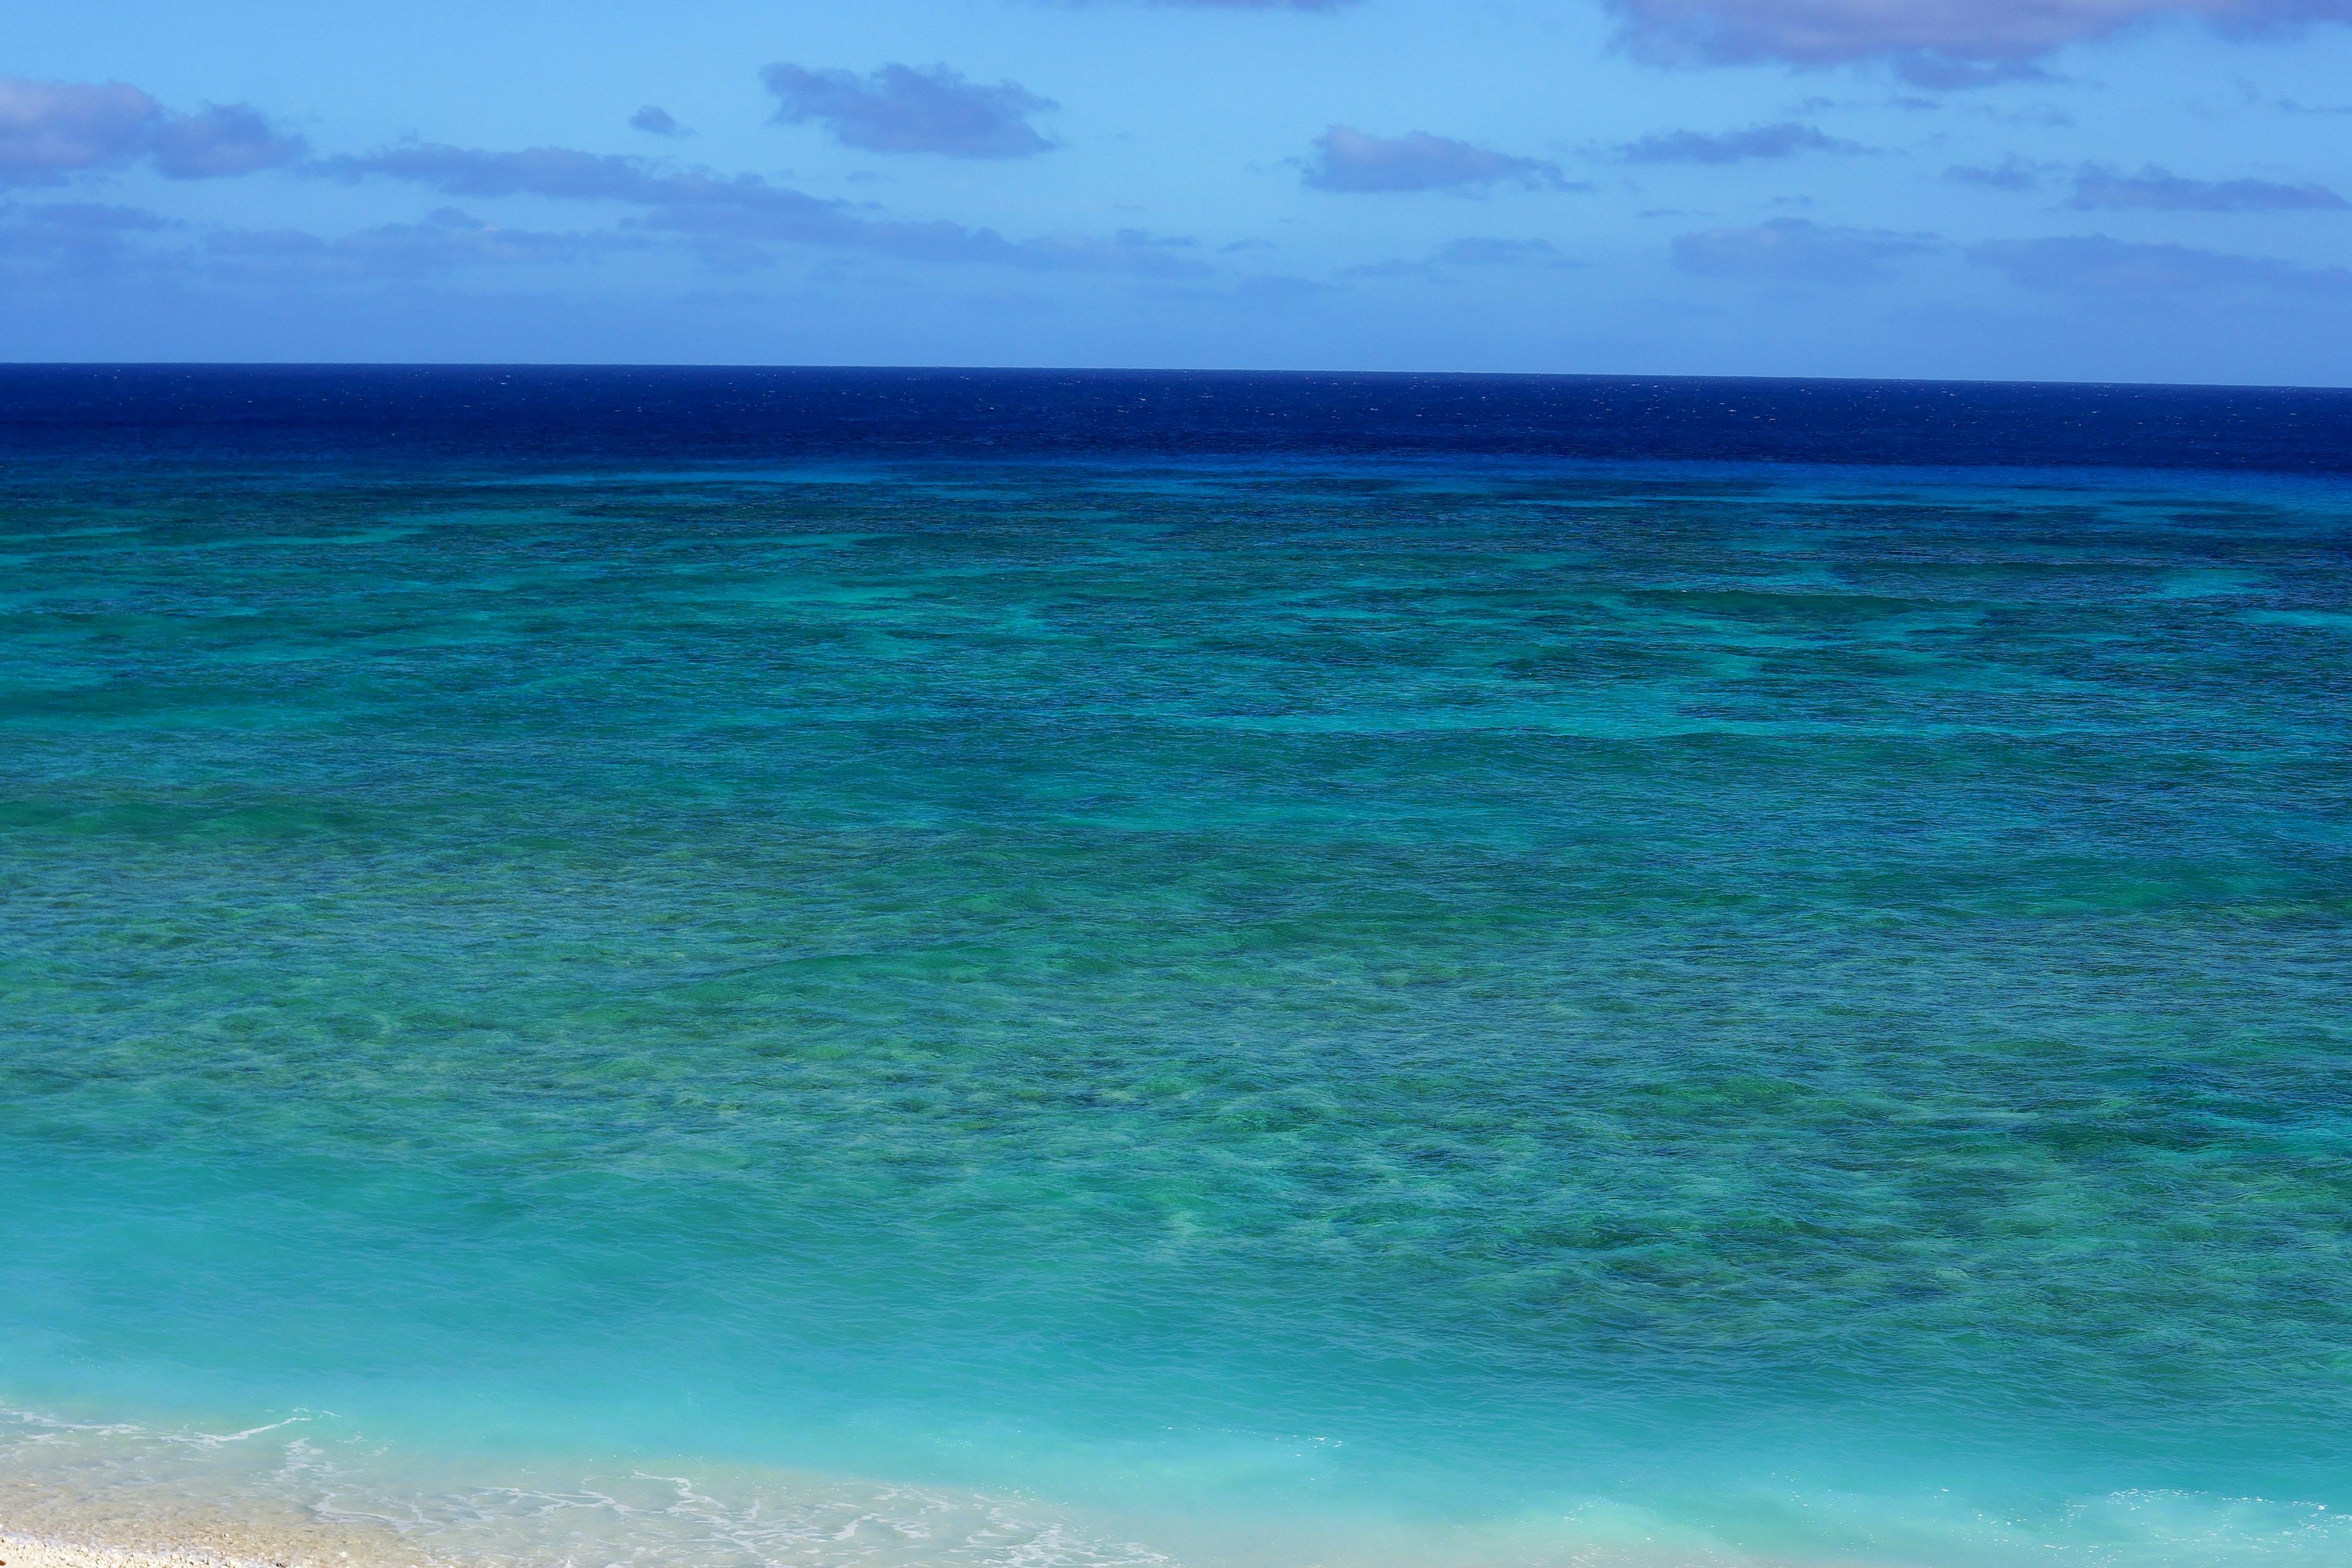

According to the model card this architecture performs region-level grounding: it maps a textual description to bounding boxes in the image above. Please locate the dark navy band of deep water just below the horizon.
[13,364,2352,475]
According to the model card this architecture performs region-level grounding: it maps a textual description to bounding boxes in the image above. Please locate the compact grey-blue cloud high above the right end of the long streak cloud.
[760,64,1058,157]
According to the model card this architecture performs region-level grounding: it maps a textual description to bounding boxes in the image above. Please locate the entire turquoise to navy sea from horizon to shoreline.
[0,367,2352,1568]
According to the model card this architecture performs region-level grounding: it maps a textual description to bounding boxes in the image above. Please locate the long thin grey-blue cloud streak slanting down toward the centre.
[313,143,1209,277]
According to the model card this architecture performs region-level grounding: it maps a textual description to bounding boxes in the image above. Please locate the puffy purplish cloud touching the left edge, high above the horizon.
[0,78,303,186]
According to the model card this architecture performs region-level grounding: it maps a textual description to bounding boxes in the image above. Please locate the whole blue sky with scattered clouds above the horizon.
[0,0,2352,385]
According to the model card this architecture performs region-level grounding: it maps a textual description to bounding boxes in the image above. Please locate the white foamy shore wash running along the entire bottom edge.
[0,1408,2352,1568]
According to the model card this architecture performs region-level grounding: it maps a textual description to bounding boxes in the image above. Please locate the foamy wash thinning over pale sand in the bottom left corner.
[0,1411,1174,1568]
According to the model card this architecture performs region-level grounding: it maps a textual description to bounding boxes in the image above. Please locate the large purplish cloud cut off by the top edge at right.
[1607,0,2352,87]
